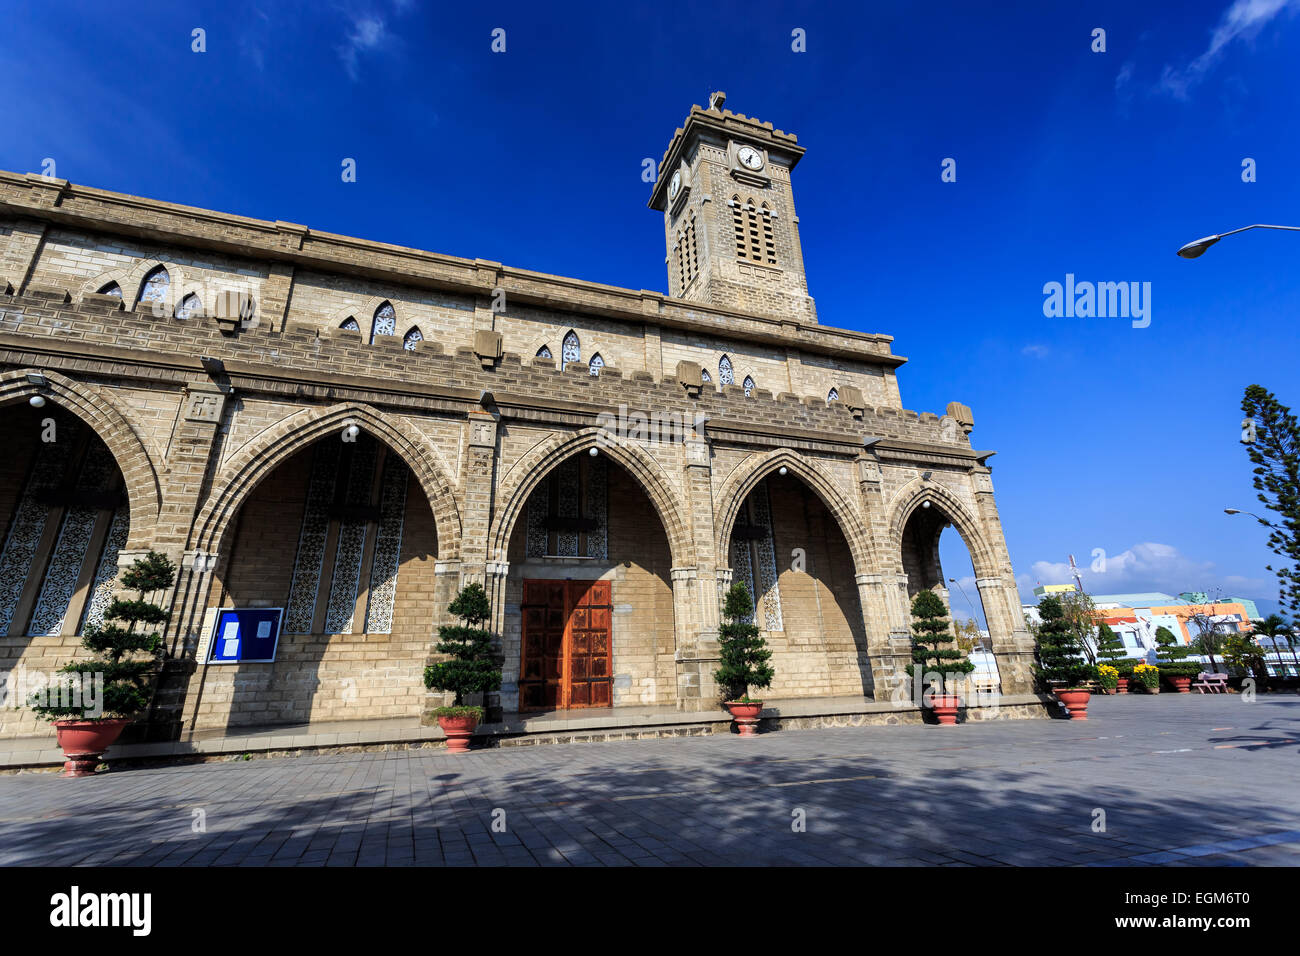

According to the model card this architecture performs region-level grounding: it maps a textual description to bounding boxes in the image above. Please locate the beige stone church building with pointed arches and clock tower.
[0,96,1031,736]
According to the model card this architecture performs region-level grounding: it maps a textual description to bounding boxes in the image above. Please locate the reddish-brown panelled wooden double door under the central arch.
[519,580,614,710]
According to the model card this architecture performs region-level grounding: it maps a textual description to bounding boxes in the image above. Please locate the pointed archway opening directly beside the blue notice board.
[191,429,439,728]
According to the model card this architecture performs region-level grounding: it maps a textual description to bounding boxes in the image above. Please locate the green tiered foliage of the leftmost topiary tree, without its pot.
[29,551,176,719]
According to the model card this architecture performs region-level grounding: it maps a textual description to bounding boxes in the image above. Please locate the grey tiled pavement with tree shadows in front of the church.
[0,695,1300,866]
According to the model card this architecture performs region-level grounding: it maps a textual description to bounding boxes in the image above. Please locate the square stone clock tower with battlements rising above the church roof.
[650,92,816,323]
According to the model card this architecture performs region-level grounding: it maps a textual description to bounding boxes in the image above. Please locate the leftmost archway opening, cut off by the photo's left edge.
[0,403,131,736]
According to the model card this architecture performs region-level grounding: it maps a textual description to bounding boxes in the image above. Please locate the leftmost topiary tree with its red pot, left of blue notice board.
[27,551,176,777]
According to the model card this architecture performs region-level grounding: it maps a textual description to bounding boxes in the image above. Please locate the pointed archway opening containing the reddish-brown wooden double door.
[502,445,676,711]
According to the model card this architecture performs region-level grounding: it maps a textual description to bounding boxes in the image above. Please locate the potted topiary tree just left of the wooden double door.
[424,583,501,753]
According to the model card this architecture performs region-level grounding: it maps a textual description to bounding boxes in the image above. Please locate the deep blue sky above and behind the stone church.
[0,0,1300,621]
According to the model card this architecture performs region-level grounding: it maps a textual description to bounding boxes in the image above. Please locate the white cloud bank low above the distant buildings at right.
[1017,541,1277,602]
